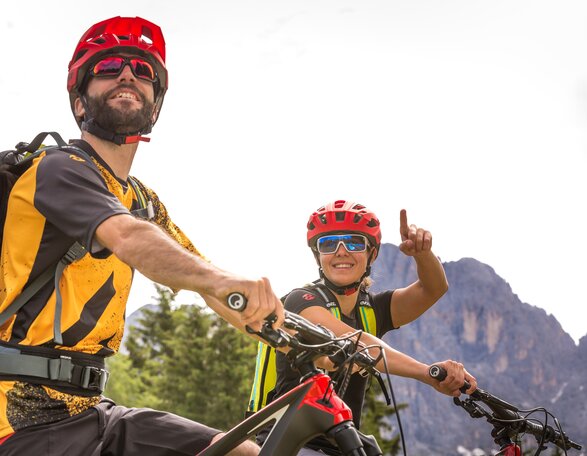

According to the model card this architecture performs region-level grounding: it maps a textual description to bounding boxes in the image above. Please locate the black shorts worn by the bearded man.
[0,399,220,456]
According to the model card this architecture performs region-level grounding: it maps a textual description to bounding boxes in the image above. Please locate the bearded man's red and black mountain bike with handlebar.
[198,293,391,456]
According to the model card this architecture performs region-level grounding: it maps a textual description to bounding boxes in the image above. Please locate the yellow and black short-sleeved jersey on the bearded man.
[0,141,200,438]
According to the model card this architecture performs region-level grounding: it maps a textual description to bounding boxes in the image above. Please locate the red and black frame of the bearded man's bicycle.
[197,373,382,456]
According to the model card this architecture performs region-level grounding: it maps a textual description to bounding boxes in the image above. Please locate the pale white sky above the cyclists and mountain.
[0,0,587,341]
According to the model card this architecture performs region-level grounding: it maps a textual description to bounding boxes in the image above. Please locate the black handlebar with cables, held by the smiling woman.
[428,364,582,450]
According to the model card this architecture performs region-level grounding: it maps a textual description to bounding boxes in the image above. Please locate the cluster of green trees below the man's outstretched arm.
[105,287,256,429]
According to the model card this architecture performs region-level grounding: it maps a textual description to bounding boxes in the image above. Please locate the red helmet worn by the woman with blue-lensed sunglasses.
[308,200,381,250]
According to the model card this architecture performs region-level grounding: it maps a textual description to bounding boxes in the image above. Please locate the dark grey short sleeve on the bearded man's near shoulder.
[34,151,129,250]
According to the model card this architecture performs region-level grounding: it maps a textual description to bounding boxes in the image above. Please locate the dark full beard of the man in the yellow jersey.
[86,84,155,134]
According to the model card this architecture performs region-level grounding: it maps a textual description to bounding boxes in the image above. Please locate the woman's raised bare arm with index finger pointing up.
[390,210,448,327]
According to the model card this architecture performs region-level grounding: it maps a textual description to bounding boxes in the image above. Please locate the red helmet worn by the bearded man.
[67,16,167,123]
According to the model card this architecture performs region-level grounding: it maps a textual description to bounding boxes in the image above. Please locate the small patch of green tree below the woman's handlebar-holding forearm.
[361,385,407,456]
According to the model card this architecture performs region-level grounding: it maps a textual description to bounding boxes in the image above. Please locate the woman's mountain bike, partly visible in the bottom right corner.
[428,365,582,456]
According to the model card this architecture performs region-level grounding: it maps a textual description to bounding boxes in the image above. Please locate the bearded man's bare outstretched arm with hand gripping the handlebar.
[95,214,283,329]
